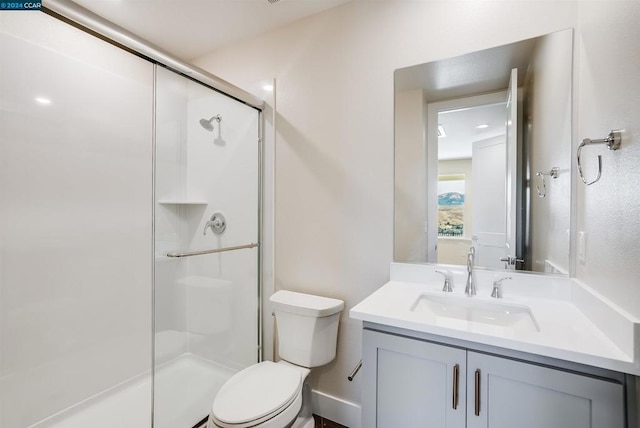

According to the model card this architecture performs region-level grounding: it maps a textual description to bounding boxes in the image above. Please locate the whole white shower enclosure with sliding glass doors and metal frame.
[0,2,261,428]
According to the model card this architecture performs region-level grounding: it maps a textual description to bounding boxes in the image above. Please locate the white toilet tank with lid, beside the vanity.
[270,290,344,368]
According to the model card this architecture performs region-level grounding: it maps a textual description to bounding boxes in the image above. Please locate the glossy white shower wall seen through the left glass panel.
[0,12,153,427]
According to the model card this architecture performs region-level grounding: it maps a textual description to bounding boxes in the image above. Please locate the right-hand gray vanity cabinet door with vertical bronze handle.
[467,351,624,428]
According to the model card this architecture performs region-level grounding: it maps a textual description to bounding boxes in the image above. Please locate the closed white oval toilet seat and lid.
[211,361,304,428]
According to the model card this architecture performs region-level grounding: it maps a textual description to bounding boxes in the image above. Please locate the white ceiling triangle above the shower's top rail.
[74,0,351,62]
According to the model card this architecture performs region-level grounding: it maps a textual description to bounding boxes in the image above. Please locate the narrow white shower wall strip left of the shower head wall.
[154,68,190,364]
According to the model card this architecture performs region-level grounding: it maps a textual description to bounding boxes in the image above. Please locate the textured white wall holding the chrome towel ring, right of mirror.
[574,1,640,317]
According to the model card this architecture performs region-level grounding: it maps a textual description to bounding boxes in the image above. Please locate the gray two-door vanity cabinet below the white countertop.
[362,329,626,428]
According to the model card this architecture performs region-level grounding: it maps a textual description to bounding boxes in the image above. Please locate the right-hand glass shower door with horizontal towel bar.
[154,67,260,428]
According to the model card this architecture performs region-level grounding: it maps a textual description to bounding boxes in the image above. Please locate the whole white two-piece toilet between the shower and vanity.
[207,290,344,428]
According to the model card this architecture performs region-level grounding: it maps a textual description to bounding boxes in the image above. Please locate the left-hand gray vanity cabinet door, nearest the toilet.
[362,330,466,428]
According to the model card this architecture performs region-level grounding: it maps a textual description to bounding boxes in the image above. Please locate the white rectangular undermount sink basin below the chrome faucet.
[411,294,540,334]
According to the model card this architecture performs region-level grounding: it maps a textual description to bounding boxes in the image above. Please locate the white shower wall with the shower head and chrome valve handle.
[184,83,259,369]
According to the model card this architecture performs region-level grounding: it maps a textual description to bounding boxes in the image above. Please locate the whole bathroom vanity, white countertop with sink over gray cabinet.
[350,263,640,428]
